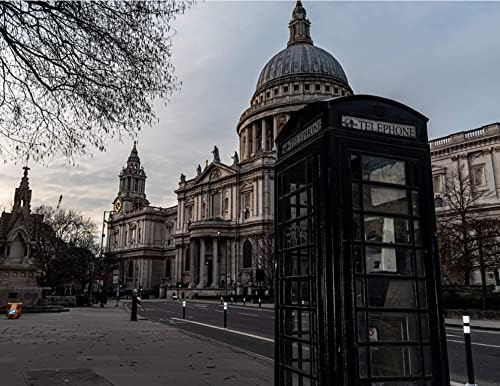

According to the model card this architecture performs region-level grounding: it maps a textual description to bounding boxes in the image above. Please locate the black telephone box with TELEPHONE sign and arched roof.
[275,95,449,386]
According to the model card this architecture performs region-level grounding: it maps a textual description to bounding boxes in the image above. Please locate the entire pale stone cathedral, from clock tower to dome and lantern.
[107,1,353,296]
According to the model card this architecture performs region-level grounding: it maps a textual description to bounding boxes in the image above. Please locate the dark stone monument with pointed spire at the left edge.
[0,167,42,306]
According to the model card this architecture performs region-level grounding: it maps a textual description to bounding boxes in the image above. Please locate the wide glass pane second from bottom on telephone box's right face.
[368,312,418,342]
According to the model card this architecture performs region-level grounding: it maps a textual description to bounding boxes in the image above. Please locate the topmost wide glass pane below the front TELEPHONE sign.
[361,155,406,185]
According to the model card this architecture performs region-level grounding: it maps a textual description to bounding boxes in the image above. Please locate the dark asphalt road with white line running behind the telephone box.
[140,302,500,386]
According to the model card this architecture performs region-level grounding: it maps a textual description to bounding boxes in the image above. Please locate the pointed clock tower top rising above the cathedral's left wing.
[113,142,149,213]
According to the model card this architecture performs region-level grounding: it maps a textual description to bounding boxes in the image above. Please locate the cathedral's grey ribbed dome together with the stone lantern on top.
[256,0,349,92]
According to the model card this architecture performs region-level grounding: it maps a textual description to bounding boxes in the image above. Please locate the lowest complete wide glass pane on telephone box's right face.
[370,346,421,377]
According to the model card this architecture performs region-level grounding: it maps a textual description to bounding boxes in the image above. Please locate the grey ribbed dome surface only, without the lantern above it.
[257,43,349,89]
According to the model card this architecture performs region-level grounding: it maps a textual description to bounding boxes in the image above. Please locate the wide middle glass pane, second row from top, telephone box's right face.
[363,185,408,214]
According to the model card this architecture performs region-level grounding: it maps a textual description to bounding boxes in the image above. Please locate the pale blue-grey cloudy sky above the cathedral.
[0,0,500,226]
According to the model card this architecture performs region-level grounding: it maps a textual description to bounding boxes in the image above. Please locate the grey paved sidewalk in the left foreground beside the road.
[0,305,273,386]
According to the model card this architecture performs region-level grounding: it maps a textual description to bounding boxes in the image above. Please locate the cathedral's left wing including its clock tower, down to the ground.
[105,143,177,293]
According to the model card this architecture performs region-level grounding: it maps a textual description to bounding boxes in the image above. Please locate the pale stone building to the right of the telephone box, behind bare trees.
[430,122,500,284]
